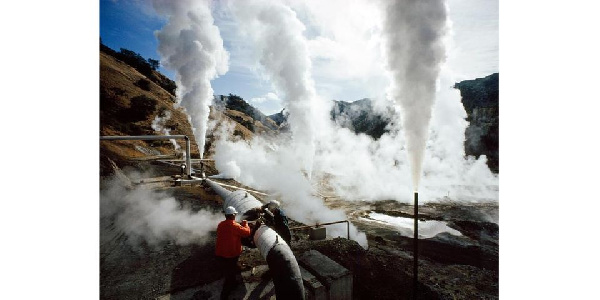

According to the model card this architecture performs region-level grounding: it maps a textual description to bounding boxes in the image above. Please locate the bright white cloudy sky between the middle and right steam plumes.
[291,0,389,101]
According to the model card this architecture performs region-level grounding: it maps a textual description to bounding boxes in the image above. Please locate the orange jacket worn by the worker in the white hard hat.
[215,220,250,258]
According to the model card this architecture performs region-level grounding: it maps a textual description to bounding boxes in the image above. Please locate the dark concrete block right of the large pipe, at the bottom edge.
[298,250,353,300]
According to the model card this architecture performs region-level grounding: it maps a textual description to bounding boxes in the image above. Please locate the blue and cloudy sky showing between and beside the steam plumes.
[100,0,499,114]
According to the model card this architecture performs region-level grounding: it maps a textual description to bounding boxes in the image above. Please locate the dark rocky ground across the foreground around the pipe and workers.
[100,165,499,299]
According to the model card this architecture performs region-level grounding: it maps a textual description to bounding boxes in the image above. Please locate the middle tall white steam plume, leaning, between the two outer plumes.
[230,0,323,177]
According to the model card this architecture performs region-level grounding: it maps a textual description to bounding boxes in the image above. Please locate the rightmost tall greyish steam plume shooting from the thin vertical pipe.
[384,0,447,191]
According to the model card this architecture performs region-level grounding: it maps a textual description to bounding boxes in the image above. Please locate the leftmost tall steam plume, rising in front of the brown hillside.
[153,0,229,158]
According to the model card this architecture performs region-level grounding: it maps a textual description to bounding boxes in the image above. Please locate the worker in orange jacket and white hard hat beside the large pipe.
[215,206,250,299]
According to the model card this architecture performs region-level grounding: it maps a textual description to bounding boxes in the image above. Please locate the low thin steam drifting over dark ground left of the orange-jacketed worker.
[100,173,223,245]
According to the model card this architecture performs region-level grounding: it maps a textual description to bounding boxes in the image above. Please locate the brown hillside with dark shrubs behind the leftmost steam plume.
[100,51,260,174]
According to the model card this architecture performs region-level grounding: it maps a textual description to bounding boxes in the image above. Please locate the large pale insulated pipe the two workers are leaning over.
[206,179,304,300]
